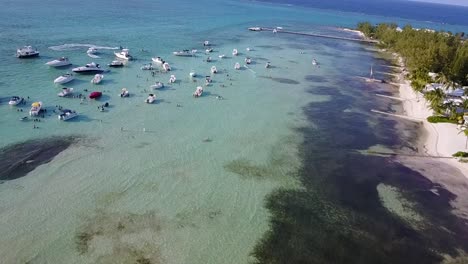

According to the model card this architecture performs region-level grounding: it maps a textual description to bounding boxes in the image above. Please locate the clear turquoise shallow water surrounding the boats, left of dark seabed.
[0,0,468,263]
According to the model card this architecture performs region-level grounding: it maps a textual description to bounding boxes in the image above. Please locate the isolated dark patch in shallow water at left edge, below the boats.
[0,137,75,181]
